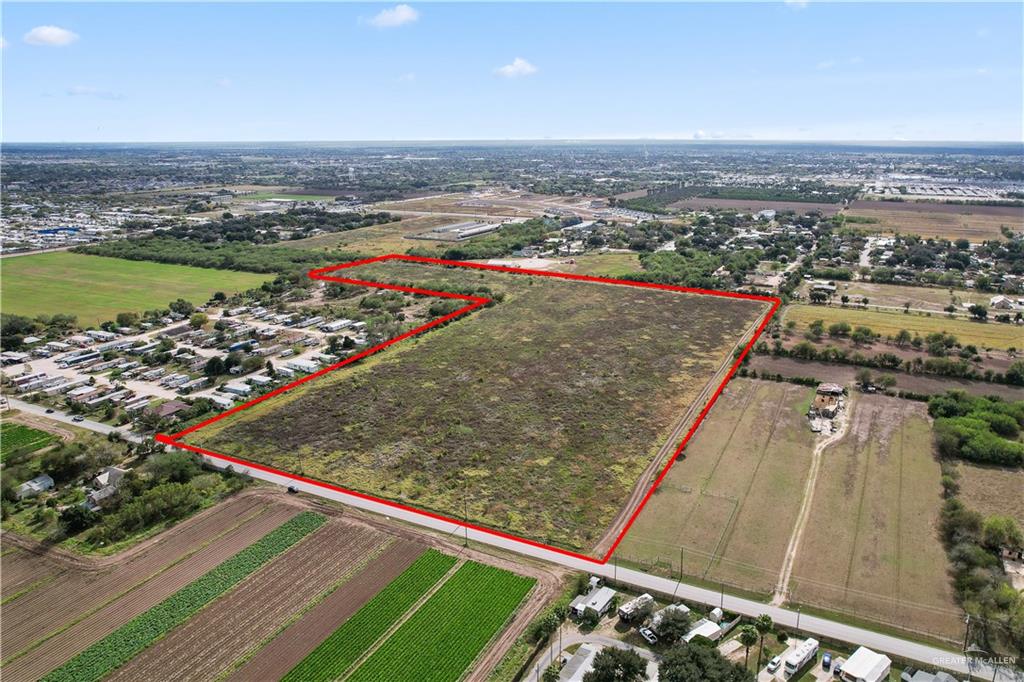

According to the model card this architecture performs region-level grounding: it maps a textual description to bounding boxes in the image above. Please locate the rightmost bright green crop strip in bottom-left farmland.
[348,562,536,682]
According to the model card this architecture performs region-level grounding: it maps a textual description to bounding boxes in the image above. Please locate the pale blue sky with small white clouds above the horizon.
[2,2,1024,141]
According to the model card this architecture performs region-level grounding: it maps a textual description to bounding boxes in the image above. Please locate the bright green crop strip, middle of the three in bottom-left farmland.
[282,550,456,682]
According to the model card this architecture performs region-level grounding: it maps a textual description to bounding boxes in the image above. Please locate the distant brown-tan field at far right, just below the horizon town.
[847,202,1024,242]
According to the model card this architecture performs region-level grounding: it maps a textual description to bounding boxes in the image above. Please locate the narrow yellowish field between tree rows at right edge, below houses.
[781,303,1024,350]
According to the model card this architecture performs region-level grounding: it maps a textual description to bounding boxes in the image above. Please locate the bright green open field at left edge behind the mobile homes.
[0,251,269,327]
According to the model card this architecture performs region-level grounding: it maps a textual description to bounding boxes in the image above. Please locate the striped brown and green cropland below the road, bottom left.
[2,491,558,682]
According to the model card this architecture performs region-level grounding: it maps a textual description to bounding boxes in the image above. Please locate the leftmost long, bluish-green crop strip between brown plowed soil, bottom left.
[43,512,327,682]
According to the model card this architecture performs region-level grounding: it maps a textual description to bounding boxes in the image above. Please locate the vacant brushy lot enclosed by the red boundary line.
[188,263,766,549]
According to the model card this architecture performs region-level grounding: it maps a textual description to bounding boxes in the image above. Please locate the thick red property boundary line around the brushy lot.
[156,254,781,565]
